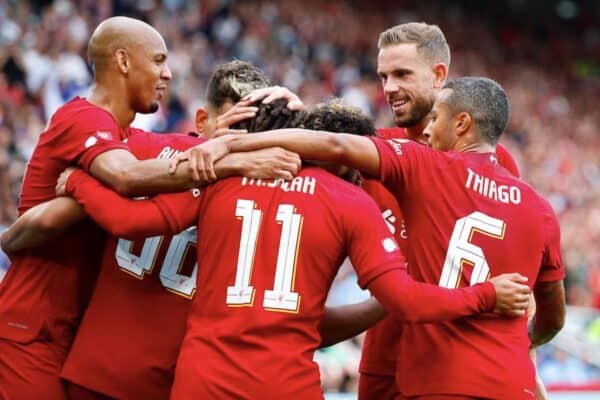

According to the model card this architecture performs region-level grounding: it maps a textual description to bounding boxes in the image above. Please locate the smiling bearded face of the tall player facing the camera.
[377,43,436,127]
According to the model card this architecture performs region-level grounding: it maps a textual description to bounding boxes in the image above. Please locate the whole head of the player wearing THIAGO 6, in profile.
[423,77,509,150]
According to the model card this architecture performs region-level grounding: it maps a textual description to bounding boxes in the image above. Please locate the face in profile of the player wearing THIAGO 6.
[423,89,460,151]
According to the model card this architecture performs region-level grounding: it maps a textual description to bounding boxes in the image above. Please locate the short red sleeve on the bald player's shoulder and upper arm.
[55,106,128,171]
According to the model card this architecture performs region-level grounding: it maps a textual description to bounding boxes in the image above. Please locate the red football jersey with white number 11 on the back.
[67,168,494,399]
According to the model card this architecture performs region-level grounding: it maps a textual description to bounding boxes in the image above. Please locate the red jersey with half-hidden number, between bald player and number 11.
[62,132,203,400]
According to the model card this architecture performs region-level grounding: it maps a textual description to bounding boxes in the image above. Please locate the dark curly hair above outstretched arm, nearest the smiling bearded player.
[304,99,375,136]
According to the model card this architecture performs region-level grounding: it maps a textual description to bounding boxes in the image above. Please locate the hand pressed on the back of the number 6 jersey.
[490,273,531,317]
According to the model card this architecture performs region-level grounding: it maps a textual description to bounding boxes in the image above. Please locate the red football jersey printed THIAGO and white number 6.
[374,139,565,399]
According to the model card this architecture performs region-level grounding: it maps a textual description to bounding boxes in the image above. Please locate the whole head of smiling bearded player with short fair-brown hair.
[377,22,450,127]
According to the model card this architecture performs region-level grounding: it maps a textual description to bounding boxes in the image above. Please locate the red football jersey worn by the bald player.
[0,98,129,354]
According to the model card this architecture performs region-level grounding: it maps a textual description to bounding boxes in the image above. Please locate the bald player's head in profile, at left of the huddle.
[88,17,172,113]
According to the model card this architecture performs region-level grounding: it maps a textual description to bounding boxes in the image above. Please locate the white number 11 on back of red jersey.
[226,200,302,312]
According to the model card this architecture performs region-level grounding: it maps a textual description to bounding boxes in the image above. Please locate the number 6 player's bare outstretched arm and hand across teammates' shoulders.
[171,129,380,180]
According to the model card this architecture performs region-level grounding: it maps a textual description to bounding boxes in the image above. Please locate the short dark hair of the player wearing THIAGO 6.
[444,76,509,145]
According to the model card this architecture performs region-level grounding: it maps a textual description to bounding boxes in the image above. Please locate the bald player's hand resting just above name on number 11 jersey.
[243,147,302,180]
